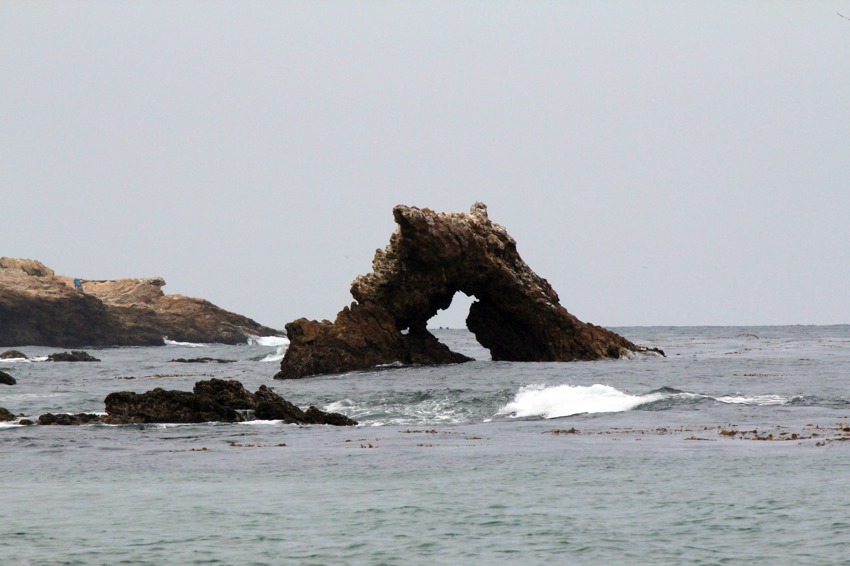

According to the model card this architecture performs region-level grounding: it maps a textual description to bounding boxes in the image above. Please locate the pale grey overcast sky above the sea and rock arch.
[0,0,850,328]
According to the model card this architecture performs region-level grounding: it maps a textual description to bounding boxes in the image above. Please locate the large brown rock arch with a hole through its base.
[275,203,662,379]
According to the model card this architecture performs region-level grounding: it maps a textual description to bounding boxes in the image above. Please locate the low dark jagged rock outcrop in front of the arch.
[104,379,357,426]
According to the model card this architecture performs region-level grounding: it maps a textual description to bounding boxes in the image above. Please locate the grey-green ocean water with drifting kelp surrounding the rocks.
[0,326,850,565]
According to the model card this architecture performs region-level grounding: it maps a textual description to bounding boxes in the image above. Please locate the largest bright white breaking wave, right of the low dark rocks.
[498,384,667,419]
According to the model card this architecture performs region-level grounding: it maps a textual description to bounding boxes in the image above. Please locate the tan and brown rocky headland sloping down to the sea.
[0,257,279,347]
